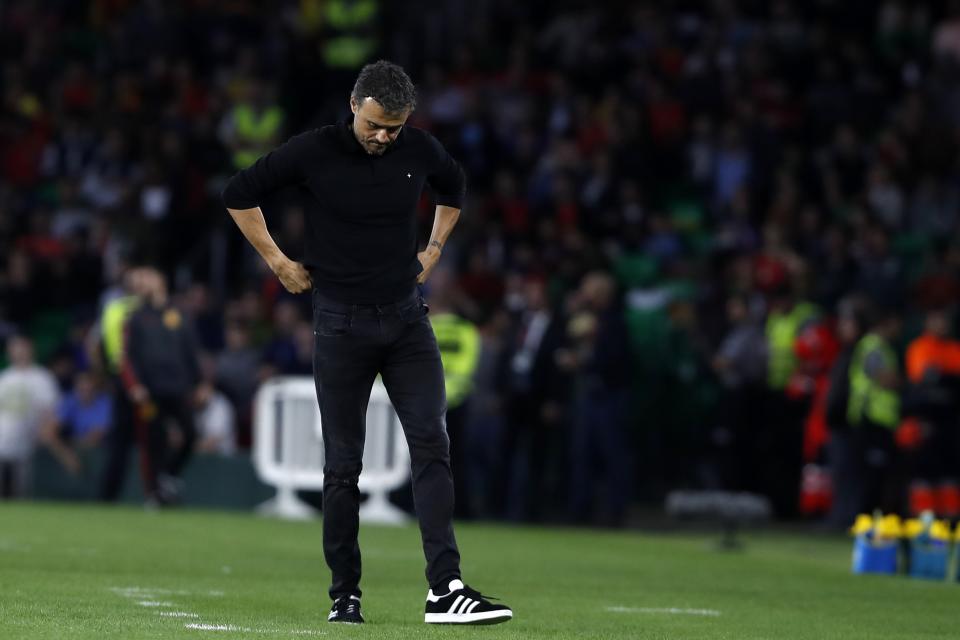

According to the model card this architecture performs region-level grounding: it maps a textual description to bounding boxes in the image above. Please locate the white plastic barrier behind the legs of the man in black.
[253,377,410,524]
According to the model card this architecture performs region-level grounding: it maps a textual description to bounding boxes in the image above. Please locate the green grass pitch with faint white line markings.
[0,503,960,640]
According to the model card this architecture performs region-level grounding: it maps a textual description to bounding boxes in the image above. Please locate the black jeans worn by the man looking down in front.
[313,291,460,599]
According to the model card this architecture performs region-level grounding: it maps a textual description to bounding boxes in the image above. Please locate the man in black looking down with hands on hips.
[223,61,513,624]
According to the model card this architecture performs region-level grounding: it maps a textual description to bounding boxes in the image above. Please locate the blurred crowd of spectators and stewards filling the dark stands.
[0,0,960,524]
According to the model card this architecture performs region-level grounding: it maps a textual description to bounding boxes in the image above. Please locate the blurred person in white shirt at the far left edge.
[0,336,60,498]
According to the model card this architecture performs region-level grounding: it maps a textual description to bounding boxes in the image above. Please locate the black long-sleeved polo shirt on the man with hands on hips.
[222,120,465,303]
